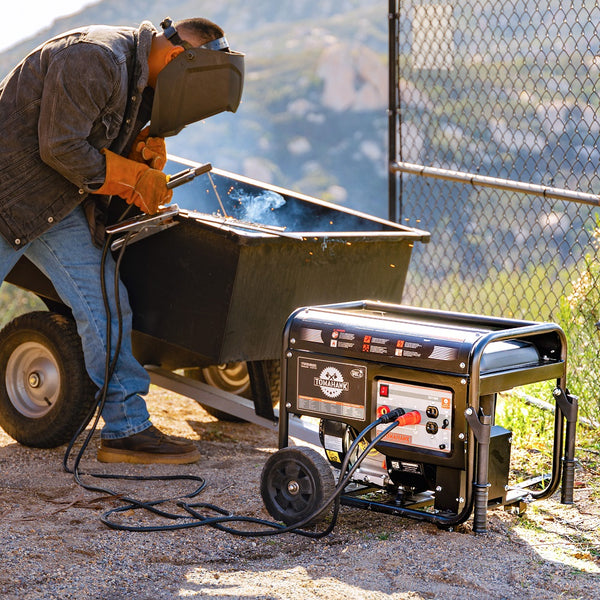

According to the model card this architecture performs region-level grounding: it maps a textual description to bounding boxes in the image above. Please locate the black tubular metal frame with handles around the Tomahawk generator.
[279,300,577,533]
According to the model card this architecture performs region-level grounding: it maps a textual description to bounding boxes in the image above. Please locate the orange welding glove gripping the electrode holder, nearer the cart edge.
[94,149,173,215]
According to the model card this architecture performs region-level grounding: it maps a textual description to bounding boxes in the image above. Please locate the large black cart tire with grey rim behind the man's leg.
[0,311,97,448]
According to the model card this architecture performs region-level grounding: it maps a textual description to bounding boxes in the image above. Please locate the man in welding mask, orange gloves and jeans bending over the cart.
[0,18,243,464]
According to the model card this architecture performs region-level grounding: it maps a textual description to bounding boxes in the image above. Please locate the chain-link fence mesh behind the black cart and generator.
[390,0,600,328]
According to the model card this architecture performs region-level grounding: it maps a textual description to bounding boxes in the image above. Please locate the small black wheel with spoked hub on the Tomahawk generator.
[260,447,335,525]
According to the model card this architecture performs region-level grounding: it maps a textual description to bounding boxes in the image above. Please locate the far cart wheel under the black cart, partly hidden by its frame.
[183,360,281,423]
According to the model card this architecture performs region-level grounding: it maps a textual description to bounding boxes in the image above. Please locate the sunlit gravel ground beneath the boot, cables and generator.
[0,387,600,600]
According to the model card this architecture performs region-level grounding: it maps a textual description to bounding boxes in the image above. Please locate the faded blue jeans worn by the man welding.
[0,208,151,439]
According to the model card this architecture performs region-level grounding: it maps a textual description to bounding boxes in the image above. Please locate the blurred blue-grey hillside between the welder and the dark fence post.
[0,0,387,216]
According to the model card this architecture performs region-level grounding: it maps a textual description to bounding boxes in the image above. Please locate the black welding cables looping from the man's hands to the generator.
[63,208,404,538]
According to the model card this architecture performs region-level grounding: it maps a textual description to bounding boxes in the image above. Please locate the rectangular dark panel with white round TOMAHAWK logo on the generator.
[297,358,367,421]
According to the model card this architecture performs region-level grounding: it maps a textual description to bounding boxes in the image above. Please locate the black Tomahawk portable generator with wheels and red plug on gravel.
[261,301,577,532]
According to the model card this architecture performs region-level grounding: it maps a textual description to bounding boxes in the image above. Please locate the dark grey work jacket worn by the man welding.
[0,22,156,249]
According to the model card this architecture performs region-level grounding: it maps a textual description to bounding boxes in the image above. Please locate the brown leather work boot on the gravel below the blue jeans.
[98,426,200,465]
